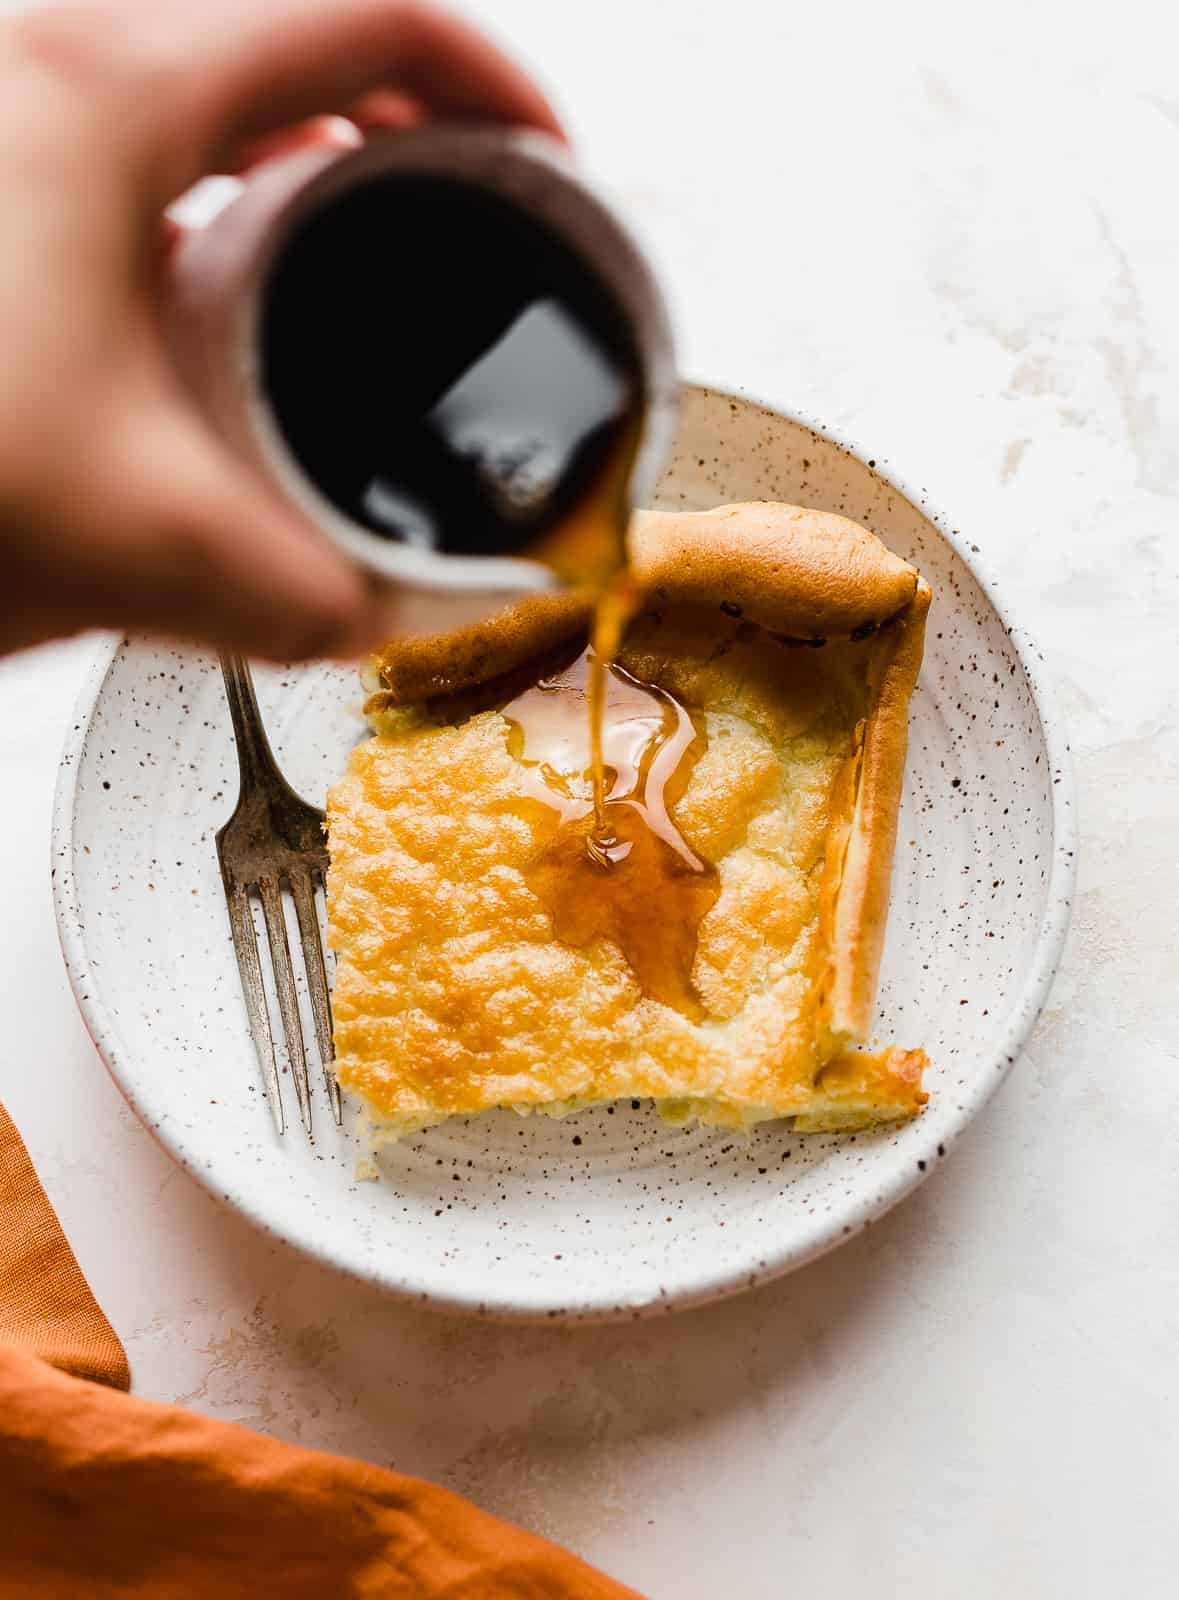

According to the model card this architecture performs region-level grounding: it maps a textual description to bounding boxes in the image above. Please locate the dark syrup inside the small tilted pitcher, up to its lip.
[259,174,645,582]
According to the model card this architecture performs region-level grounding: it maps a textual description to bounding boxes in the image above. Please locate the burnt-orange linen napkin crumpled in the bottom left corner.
[0,1107,637,1600]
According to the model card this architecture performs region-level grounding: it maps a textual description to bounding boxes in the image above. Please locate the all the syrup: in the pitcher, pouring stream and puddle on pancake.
[259,176,718,1019]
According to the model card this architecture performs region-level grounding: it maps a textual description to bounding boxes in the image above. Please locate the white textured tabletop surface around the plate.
[0,0,1179,1600]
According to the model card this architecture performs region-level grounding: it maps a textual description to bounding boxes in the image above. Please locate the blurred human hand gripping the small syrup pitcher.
[0,0,560,659]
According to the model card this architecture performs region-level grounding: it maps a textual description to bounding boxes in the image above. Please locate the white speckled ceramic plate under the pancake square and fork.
[53,380,1073,1318]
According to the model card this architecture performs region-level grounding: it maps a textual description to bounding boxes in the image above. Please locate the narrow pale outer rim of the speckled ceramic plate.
[50,379,1077,1322]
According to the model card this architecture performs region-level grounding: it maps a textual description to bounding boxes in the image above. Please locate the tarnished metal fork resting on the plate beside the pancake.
[218,653,341,1136]
